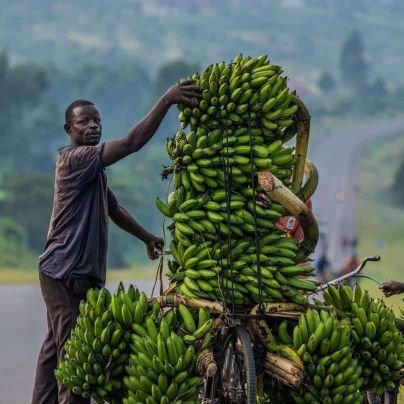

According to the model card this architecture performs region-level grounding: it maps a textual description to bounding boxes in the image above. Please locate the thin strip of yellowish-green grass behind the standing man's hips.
[0,264,157,285]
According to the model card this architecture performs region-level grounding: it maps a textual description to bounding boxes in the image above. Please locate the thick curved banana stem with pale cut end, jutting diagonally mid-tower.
[258,171,319,261]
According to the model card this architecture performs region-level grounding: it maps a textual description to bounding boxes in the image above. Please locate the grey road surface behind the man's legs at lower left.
[0,281,153,404]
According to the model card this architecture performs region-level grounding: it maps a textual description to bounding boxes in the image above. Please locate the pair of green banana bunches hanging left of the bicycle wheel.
[55,283,213,404]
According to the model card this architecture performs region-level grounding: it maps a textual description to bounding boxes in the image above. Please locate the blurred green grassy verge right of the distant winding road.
[358,136,404,312]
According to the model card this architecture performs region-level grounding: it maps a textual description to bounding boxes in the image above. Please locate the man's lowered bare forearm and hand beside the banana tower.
[109,204,164,259]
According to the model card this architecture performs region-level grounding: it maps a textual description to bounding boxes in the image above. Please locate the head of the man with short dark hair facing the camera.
[64,100,102,146]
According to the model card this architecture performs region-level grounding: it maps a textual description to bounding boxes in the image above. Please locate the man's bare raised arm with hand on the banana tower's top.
[102,80,200,166]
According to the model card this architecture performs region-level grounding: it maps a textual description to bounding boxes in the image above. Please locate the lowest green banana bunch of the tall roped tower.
[170,232,317,304]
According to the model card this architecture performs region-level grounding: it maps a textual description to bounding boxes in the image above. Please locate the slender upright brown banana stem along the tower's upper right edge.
[292,95,310,193]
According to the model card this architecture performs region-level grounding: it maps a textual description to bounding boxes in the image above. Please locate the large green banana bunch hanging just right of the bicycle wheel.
[274,309,363,404]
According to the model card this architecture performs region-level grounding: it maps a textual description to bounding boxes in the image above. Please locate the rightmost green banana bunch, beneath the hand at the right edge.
[323,284,404,395]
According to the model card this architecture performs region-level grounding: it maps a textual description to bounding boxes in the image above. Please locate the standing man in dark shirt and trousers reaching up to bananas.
[32,80,200,404]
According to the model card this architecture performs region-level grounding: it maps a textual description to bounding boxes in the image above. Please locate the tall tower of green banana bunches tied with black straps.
[156,55,316,305]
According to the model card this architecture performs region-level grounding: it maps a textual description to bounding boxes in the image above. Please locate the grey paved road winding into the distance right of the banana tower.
[309,118,404,270]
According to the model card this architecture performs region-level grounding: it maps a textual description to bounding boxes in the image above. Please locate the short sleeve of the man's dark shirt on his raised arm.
[69,143,105,184]
